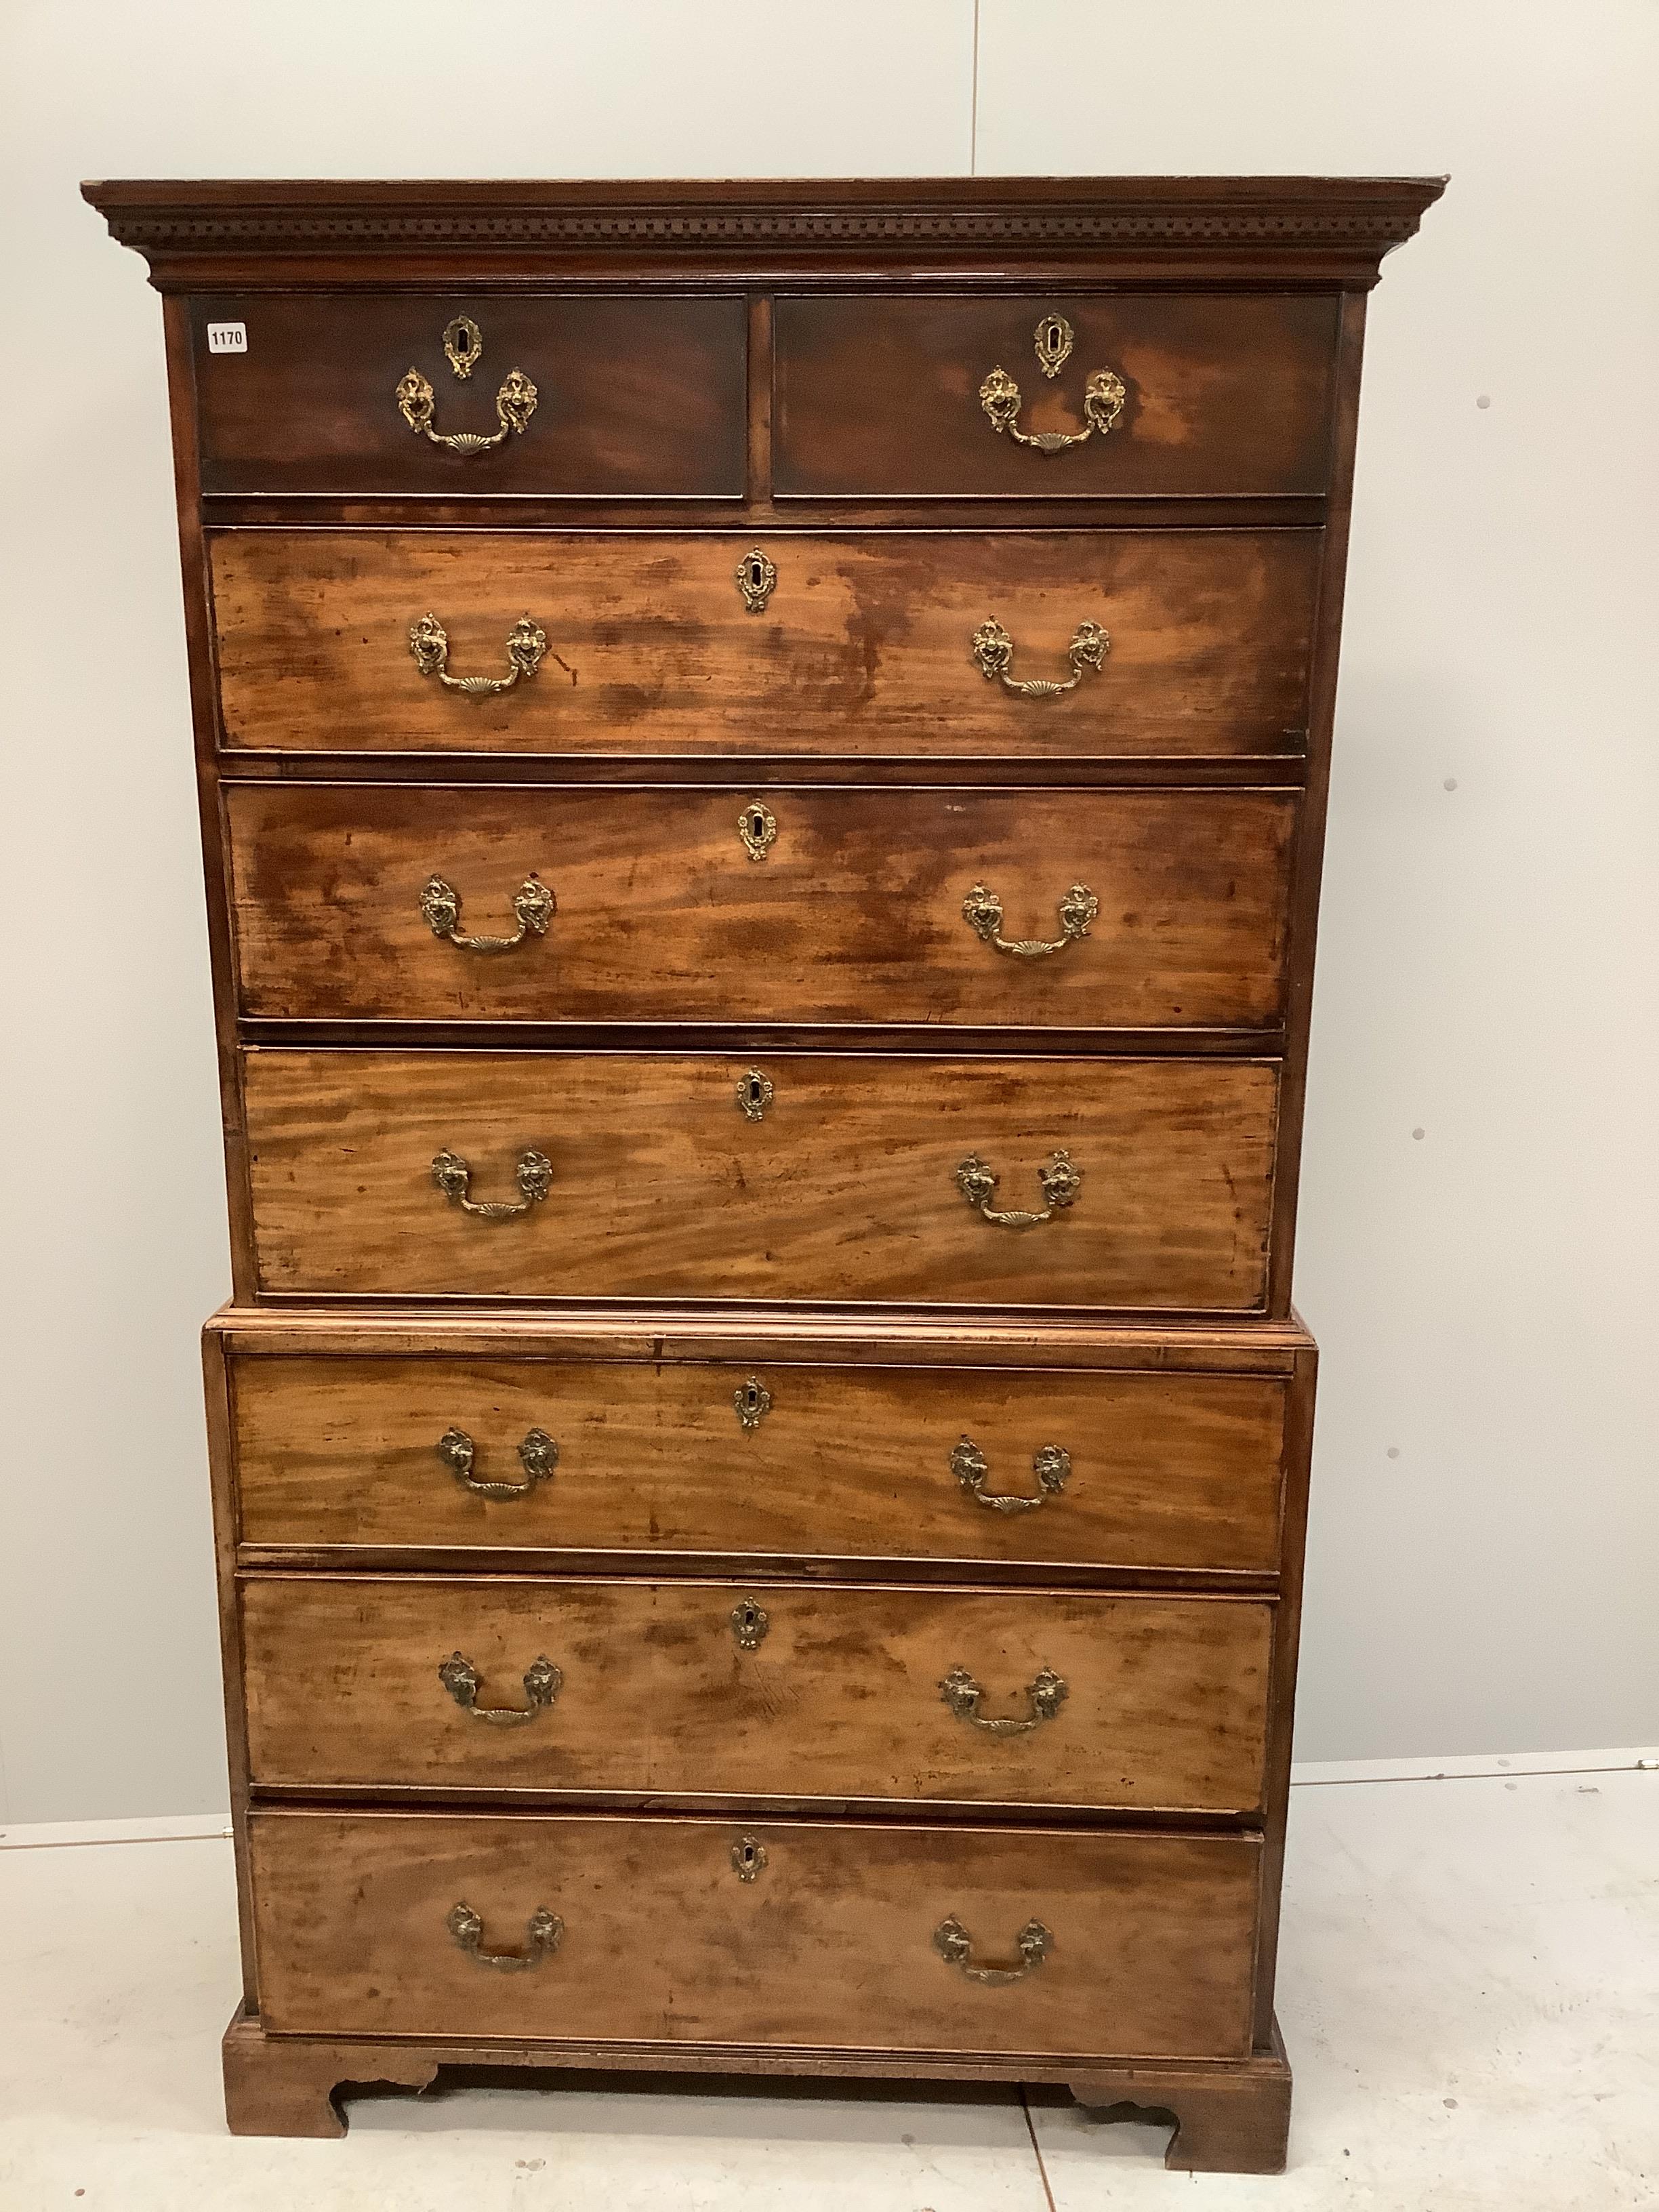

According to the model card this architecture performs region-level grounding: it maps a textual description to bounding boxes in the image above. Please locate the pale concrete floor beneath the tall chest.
[0,1754,1659,2212]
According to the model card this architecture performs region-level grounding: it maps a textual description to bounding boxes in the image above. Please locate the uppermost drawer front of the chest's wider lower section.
[232,1356,1285,1573]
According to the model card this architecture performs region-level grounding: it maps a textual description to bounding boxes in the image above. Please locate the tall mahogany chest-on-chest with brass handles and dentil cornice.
[86,179,1440,2170]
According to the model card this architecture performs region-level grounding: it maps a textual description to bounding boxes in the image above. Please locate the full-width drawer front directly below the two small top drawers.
[210,529,1318,759]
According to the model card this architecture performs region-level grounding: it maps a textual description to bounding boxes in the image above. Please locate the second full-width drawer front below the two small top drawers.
[228,783,1296,1029]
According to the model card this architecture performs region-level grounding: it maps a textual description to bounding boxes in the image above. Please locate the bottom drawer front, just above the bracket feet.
[250,1811,1261,2057]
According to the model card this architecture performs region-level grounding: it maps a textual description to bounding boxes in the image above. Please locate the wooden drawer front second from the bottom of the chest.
[241,1575,1272,1814]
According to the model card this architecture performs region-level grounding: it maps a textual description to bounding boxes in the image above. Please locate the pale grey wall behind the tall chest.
[0,0,1659,1820]
